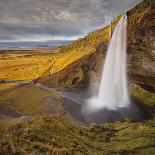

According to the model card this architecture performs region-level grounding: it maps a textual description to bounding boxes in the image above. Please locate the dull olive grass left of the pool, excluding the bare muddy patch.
[0,85,62,115]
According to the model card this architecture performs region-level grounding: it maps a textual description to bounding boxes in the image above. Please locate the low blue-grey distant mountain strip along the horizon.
[0,40,72,48]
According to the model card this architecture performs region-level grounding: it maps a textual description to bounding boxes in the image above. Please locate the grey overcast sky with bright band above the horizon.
[0,0,141,42]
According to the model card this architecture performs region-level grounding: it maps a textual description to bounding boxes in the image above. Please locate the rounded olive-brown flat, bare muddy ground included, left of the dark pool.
[0,85,63,118]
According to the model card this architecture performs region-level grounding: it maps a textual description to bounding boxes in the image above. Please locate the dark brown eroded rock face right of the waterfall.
[127,0,155,88]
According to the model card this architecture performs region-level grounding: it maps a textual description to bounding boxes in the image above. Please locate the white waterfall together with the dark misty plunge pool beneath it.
[82,15,146,123]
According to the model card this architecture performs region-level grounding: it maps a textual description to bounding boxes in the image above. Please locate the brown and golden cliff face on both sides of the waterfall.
[39,0,155,103]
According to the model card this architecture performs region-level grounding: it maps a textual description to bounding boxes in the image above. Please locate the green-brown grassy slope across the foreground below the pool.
[0,116,155,155]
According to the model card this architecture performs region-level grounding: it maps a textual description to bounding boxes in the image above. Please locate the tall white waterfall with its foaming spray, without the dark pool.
[87,15,130,111]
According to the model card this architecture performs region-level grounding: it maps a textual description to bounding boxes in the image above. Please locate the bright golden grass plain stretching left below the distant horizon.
[0,49,92,80]
